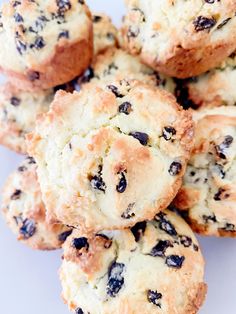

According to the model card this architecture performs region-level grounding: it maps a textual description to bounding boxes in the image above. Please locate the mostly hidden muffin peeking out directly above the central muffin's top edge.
[78,47,176,93]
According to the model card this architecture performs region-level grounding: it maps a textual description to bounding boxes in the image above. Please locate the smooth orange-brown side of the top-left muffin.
[0,34,93,91]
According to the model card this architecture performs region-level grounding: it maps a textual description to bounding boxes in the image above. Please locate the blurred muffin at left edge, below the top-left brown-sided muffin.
[0,83,54,154]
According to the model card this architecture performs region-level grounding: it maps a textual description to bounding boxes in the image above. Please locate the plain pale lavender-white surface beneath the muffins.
[0,0,236,314]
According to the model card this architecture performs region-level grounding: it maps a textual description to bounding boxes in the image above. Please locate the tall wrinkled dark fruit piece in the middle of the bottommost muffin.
[107,262,125,298]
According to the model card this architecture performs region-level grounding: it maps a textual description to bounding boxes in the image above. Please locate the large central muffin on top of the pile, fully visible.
[27,80,193,231]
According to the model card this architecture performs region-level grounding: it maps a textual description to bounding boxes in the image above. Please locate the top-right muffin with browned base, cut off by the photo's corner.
[121,0,236,78]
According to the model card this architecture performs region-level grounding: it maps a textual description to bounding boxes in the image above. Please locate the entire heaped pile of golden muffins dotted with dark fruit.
[0,0,236,314]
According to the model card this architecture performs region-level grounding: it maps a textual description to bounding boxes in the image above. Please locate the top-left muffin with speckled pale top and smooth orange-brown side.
[0,0,93,90]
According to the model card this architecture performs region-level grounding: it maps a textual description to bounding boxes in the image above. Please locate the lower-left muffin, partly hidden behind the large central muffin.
[2,157,72,250]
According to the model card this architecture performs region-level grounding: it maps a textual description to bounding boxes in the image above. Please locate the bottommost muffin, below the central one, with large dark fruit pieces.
[60,210,206,314]
